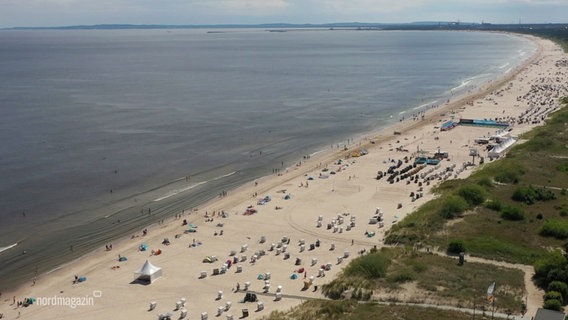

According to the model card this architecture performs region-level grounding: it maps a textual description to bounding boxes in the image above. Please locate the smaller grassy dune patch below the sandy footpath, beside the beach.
[322,244,524,312]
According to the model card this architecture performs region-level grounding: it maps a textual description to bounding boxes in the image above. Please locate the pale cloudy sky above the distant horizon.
[0,0,568,28]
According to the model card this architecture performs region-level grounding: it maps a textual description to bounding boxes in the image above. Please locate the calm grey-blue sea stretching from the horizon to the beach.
[0,29,536,290]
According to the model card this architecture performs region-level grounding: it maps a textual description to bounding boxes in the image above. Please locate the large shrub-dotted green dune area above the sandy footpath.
[385,99,568,264]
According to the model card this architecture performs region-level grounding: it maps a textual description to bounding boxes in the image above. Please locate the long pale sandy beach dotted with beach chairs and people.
[0,33,568,320]
